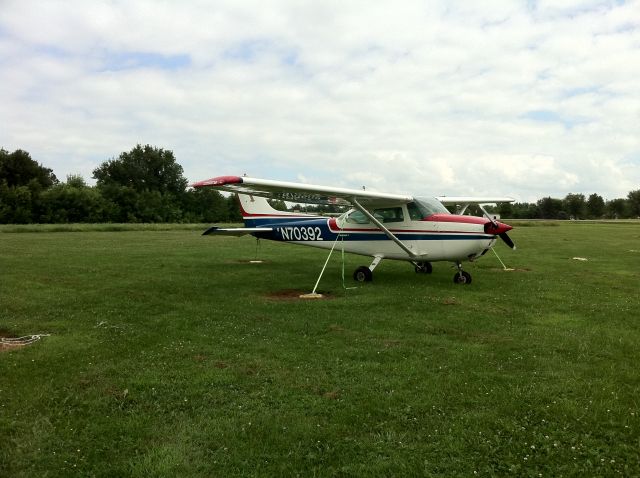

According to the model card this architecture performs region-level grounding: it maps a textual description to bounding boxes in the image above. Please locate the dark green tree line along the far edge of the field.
[0,144,640,224]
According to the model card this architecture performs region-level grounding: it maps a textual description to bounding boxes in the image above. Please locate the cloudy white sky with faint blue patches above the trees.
[0,0,640,201]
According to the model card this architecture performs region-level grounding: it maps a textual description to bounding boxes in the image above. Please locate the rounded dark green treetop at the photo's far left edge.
[0,149,58,189]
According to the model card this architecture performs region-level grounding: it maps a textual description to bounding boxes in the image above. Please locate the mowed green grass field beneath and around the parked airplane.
[0,222,640,477]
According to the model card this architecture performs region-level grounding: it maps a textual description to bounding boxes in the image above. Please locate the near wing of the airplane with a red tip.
[191,176,413,206]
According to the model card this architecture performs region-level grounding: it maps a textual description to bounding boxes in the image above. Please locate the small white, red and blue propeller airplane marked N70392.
[191,176,515,284]
